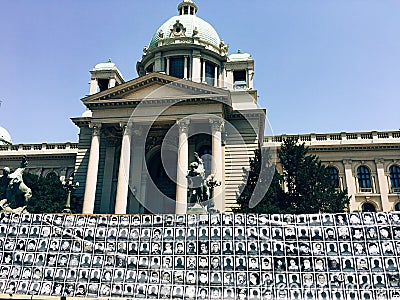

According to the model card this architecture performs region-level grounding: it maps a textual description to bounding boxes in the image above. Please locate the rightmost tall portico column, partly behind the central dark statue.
[210,119,225,212]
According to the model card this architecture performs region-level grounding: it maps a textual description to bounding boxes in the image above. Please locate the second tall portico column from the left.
[115,124,131,214]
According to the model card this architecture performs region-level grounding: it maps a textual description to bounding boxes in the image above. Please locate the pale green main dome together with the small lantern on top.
[148,0,223,52]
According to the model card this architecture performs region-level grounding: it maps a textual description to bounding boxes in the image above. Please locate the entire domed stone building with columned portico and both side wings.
[0,0,400,214]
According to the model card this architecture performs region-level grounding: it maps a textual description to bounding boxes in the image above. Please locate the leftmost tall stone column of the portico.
[82,123,101,214]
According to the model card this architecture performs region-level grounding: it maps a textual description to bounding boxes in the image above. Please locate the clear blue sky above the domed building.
[0,0,400,143]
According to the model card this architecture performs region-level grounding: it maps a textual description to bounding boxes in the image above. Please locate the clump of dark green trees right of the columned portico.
[235,139,349,214]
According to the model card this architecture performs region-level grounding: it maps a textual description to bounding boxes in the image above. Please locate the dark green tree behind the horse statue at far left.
[24,173,67,213]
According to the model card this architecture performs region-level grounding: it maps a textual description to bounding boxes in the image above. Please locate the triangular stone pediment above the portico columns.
[82,73,230,107]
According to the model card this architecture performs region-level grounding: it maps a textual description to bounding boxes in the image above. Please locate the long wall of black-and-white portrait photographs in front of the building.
[0,213,400,299]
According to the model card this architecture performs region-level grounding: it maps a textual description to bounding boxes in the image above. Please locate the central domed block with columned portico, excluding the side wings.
[73,1,265,214]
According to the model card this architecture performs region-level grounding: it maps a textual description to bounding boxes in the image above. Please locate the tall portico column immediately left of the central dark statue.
[175,119,189,214]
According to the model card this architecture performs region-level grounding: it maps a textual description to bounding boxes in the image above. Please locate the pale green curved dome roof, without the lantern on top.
[148,15,221,50]
